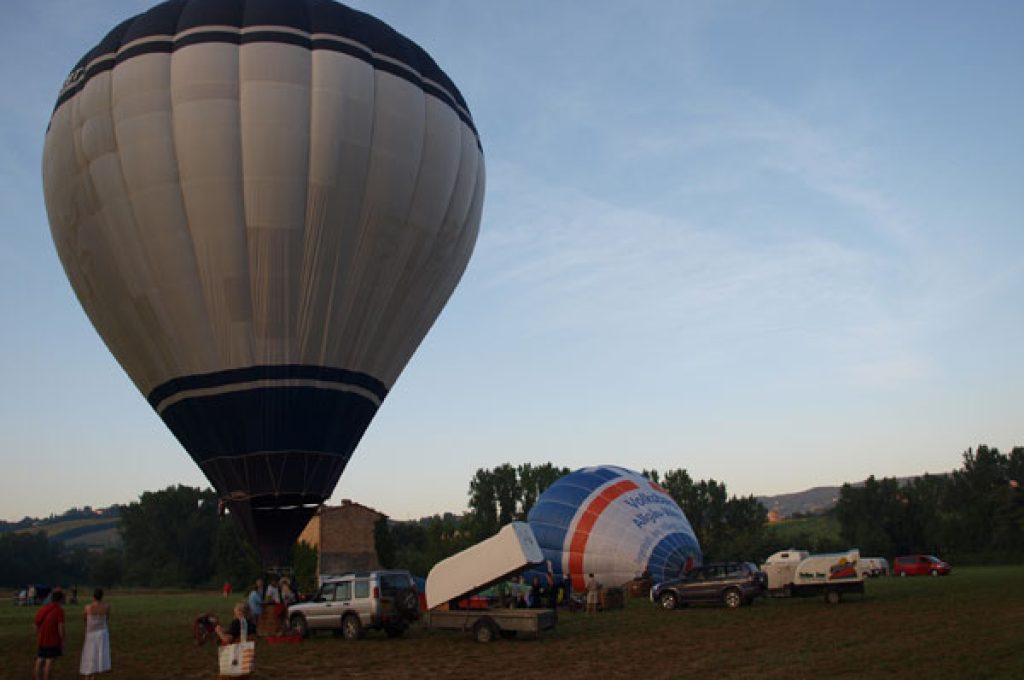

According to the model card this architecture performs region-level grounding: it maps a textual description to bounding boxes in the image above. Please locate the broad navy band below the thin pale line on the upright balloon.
[160,386,378,462]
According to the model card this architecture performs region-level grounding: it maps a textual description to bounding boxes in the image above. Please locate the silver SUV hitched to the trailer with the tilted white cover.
[288,569,420,640]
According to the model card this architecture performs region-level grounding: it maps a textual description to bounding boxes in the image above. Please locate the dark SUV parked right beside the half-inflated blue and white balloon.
[650,562,767,609]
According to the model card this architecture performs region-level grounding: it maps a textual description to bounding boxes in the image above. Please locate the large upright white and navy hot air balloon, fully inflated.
[43,0,484,563]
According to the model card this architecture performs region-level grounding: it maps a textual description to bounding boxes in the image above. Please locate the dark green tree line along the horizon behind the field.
[0,445,1024,591]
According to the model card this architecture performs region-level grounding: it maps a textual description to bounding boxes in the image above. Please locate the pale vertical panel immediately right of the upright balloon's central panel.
[298,50,380,368]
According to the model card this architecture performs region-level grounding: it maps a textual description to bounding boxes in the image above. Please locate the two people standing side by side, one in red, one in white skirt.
[34,587,111,680]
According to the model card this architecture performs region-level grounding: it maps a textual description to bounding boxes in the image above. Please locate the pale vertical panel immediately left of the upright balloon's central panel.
[170,43,253,373]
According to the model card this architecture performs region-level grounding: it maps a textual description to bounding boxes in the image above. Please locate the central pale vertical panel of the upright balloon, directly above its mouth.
[239,42,311,365]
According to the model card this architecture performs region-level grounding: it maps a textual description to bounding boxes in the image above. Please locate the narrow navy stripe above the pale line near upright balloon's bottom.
[146,364,387,409]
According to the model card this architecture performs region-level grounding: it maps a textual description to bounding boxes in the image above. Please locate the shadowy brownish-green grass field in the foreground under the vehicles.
[0,566,1024,680]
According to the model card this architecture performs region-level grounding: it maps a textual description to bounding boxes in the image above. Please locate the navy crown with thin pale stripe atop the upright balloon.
[54,0,480,146]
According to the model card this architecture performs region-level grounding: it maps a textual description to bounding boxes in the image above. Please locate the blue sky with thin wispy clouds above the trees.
[0,0,1024,520]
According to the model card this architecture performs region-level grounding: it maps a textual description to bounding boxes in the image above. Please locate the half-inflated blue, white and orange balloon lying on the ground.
[527,466,701,591]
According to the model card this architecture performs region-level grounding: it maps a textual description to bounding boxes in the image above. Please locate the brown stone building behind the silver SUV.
[299,499,387,575]
